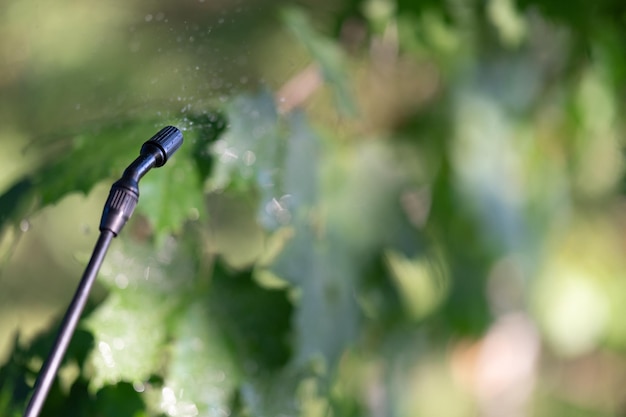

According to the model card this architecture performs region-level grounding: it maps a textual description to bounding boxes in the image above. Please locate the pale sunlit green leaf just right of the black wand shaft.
[86,239,196,388]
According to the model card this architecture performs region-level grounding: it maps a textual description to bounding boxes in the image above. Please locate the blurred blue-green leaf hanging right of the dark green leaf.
[271,224,359,373]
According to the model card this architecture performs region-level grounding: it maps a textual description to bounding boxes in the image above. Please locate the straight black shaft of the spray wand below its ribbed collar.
[24,230,114,417]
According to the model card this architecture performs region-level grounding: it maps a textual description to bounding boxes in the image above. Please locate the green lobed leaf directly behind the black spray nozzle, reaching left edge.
[0,115,212,241]
